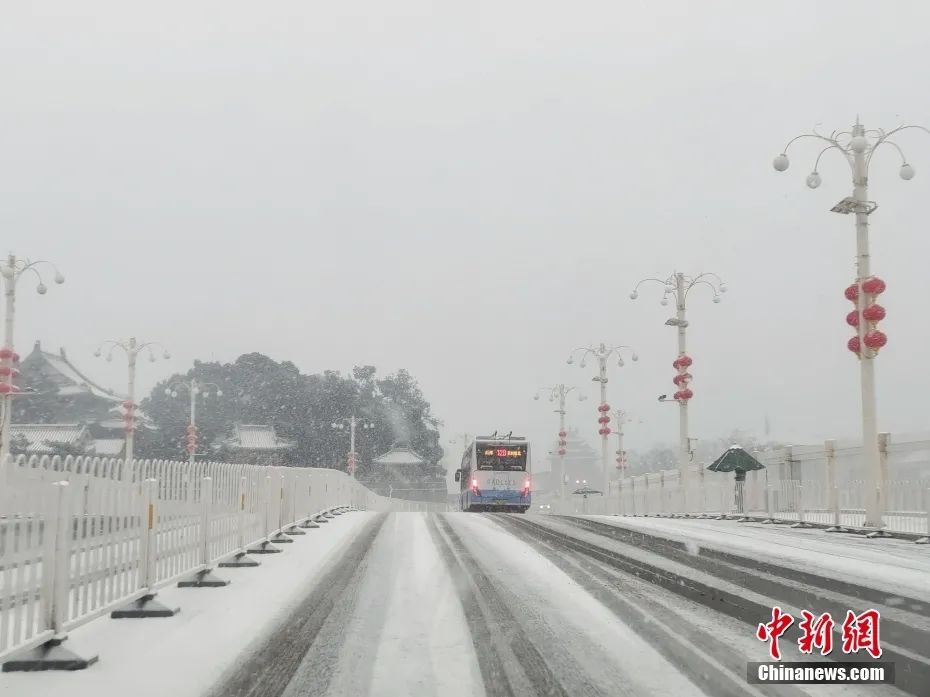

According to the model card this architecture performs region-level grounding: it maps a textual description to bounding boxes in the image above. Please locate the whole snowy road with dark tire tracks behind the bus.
[203,513,930,697]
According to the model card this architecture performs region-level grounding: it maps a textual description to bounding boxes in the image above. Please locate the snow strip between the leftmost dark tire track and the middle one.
[282,513,484,697]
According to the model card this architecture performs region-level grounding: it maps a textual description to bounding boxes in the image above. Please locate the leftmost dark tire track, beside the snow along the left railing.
[210,514,387,697]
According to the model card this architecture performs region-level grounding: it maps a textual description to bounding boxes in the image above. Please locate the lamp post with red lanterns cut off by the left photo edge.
[0,254,65,463]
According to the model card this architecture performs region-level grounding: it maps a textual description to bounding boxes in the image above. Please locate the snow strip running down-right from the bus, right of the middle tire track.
[448,514,704,697]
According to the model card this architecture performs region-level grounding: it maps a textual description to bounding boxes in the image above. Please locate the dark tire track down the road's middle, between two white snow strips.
[429,515,577,697]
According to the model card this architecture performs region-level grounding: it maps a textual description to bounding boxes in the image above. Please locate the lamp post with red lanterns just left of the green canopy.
[630,271,727,513]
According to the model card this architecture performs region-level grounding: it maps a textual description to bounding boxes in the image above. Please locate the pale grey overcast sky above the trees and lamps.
[0,0,930,474]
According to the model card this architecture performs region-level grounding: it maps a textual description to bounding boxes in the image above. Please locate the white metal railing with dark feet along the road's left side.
[0,456,447,662]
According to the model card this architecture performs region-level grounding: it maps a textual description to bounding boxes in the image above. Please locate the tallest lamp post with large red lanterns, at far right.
[772,118,930,527]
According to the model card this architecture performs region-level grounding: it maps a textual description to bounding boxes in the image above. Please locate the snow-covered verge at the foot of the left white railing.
[0,512,375,697]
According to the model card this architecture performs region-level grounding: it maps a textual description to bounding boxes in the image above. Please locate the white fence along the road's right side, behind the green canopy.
[551,434,930,537]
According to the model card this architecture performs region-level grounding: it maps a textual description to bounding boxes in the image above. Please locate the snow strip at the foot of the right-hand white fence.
[589,516,930,600]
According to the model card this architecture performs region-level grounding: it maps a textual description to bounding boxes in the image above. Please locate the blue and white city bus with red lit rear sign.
[455,434,532,513]
